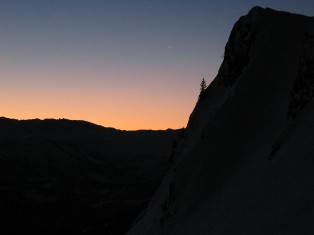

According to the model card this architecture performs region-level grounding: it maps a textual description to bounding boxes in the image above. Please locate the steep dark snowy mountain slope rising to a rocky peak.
[128,7,314,235]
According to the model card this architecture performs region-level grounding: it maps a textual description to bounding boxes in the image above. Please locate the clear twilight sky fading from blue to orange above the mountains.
[0,0,314,130]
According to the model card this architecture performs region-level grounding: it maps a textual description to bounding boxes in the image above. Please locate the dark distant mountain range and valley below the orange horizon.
[0,118,178,234]
